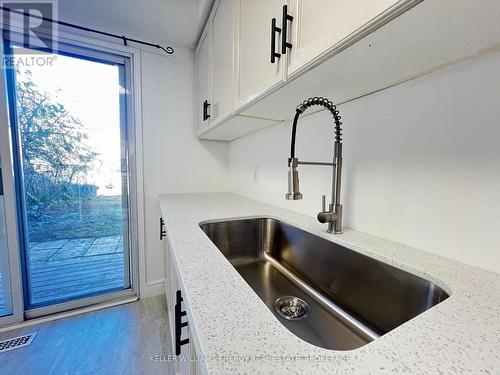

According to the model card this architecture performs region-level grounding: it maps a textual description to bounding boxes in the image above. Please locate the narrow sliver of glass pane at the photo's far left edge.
[0,168,12,317]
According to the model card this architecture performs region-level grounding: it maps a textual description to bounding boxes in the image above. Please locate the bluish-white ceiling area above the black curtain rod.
[58,0,211,47]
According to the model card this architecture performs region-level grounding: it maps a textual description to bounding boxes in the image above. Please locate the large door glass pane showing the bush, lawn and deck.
[7,48,130,307]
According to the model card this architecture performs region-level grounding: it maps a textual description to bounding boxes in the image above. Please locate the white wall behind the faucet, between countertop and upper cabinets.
[229,53,500,272]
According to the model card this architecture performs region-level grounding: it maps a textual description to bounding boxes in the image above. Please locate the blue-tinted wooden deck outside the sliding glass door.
[0,236,128,316]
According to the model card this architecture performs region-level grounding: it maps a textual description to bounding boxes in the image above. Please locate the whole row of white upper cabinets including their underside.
[196,0,500,140]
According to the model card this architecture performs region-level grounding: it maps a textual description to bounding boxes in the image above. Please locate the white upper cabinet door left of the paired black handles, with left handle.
[236,0,286,106]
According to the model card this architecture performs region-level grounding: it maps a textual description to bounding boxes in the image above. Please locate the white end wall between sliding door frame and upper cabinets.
[141,46,227,294]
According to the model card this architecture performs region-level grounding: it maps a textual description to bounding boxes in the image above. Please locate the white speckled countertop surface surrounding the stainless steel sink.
[159,193,500,375]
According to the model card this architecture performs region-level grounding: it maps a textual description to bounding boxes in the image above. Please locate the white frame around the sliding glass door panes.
[0,22,146,325]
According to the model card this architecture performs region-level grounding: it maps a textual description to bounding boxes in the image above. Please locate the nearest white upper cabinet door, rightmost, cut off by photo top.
[288,0,399,75]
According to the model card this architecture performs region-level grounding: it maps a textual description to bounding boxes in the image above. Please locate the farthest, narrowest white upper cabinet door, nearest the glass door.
[196,23,212,130]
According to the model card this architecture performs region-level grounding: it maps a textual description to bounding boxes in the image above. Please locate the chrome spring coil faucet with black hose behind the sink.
[286,97,343,234]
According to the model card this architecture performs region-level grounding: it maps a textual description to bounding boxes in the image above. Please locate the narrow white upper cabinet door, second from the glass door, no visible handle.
[210,0,234,125]
